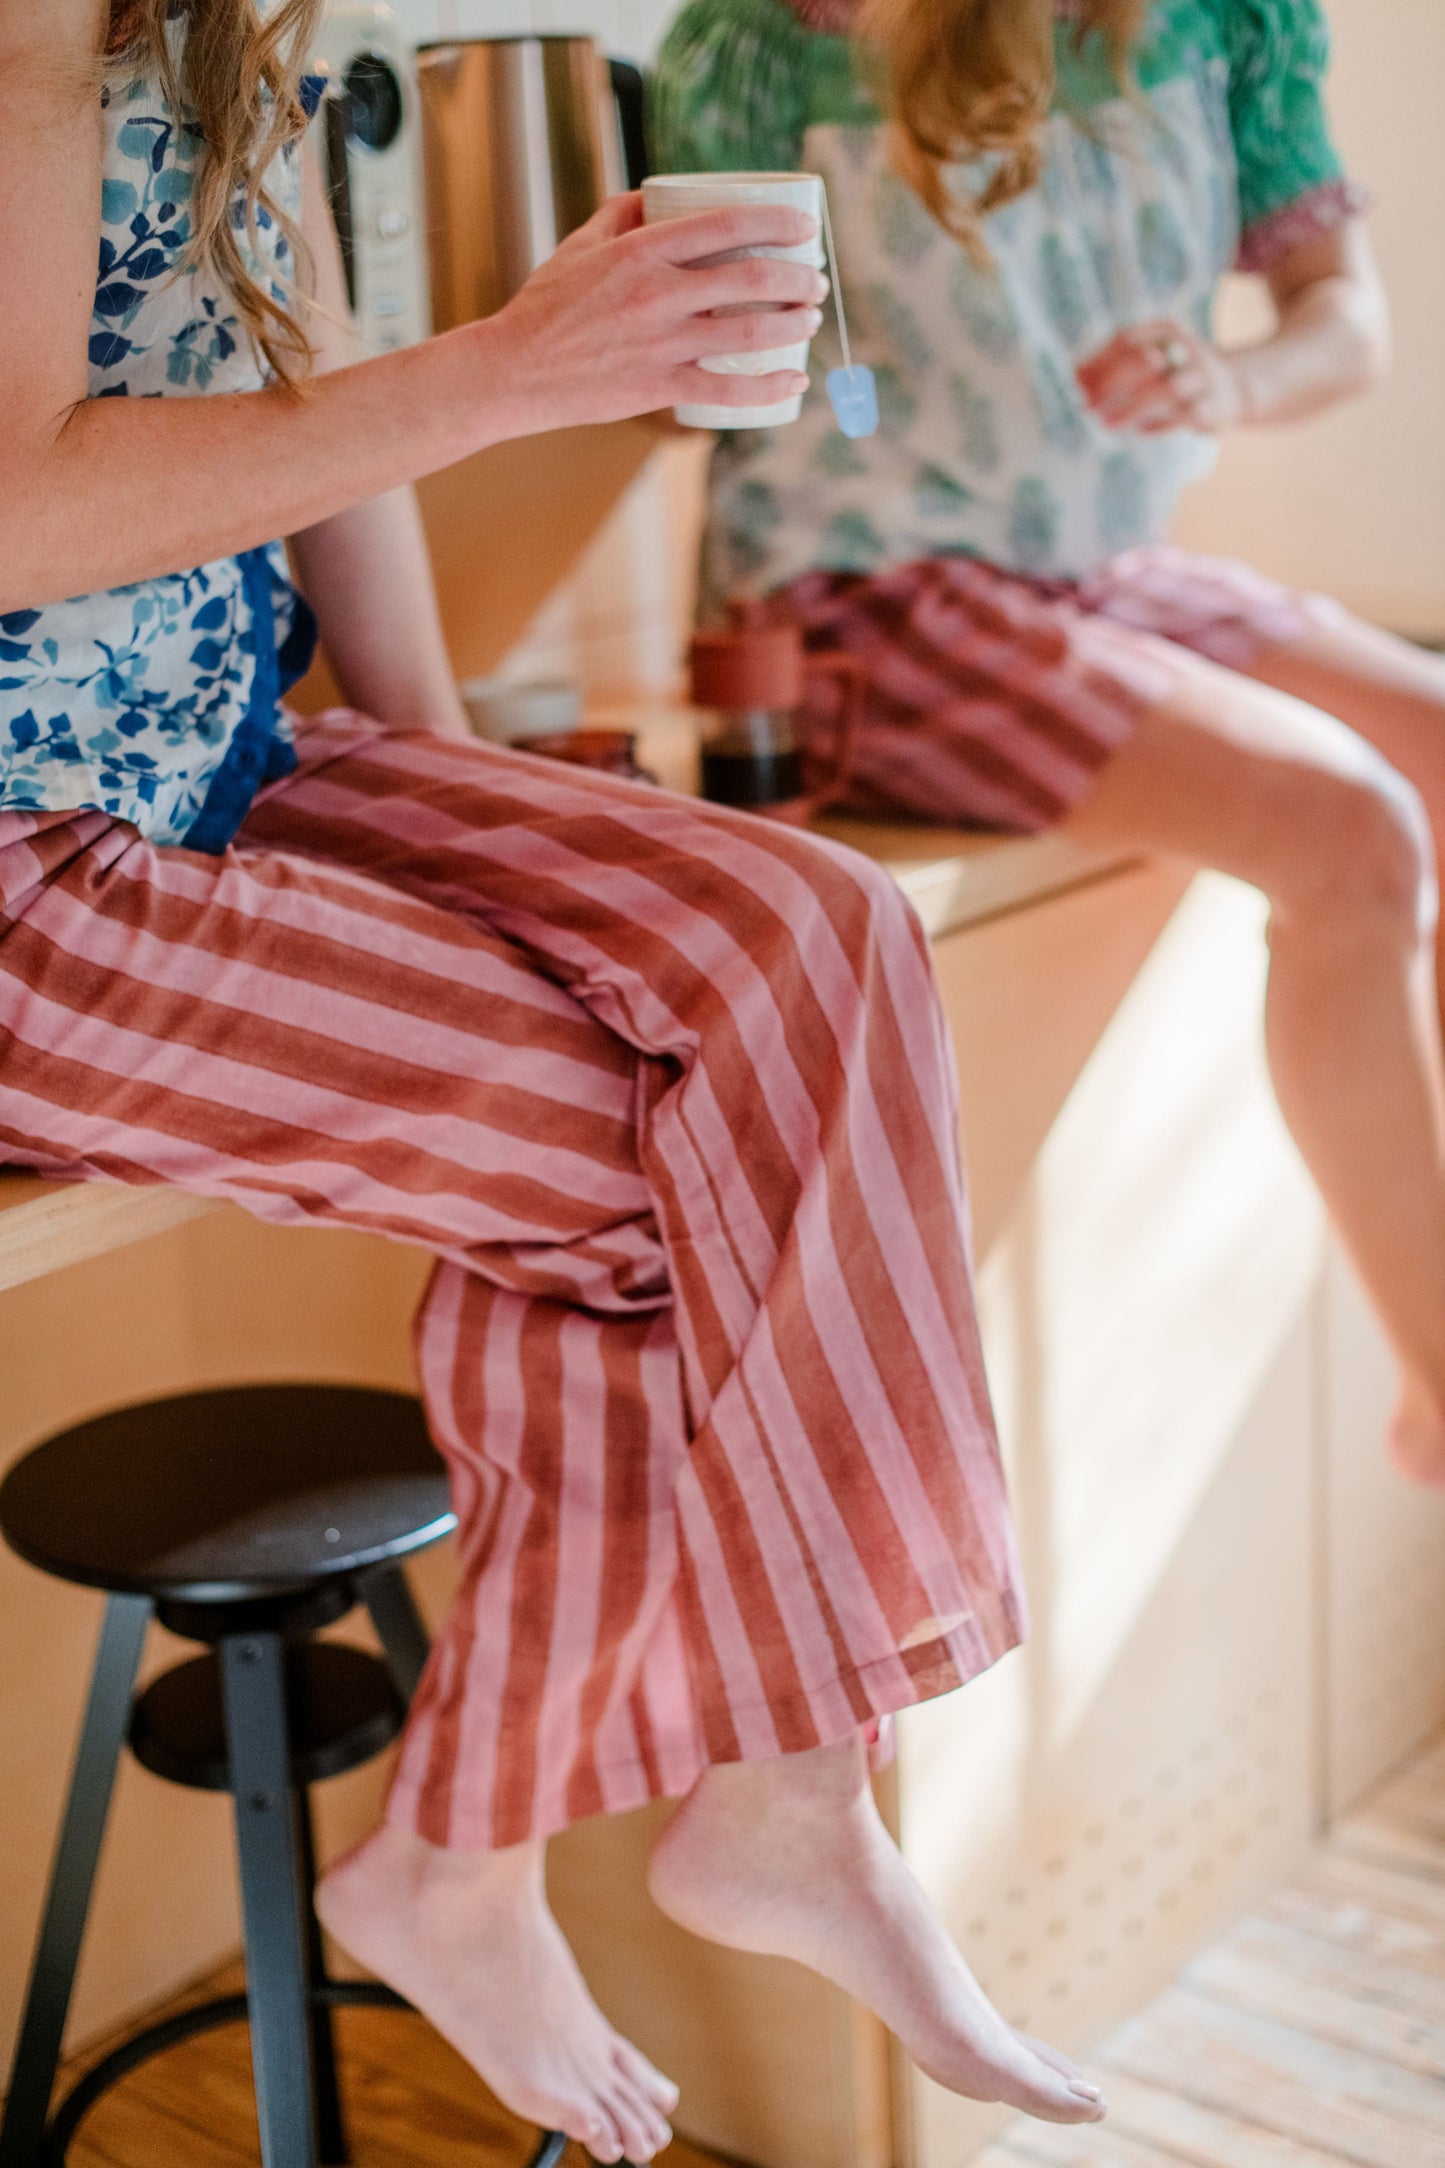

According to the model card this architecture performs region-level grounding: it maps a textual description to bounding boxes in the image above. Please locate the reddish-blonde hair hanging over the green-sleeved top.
[858,0,1148,262]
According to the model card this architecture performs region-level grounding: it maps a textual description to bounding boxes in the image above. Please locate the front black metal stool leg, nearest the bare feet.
[221,1633,316,2168]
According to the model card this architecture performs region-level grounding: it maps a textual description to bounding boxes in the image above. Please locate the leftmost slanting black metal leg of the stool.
[0,1596,152,2168]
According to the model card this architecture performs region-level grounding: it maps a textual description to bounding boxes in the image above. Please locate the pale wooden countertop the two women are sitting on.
[0,719,1127,1292]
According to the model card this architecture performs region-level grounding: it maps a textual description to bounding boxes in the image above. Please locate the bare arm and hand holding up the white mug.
[0,0,823,611]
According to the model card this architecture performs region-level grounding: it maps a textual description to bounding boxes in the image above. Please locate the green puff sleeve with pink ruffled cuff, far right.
[1224,0,1369,271]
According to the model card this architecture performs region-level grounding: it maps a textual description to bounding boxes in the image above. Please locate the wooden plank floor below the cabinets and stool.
[53,1741,1445,2168]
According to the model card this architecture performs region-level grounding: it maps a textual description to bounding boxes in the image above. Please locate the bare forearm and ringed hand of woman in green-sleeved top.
[1079,223,1389,436]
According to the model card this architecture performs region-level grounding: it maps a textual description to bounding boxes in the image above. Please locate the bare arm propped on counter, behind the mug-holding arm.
[290,146,468,737]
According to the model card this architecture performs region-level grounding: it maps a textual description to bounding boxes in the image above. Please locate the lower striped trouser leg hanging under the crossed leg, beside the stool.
[400,1264,706,1847]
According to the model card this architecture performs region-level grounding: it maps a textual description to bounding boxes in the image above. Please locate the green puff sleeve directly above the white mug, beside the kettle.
[648,0,817,173]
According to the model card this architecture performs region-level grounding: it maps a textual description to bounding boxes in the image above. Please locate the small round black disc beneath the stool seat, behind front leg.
[130,1641,407,1791]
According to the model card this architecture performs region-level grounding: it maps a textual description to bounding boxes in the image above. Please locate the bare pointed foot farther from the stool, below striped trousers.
[650,1739,1105,2122]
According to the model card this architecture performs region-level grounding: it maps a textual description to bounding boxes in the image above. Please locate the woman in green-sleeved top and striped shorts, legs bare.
[654,0,1445,1485]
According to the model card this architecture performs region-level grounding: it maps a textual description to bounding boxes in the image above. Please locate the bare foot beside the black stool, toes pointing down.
[316,1828,678,2161]
